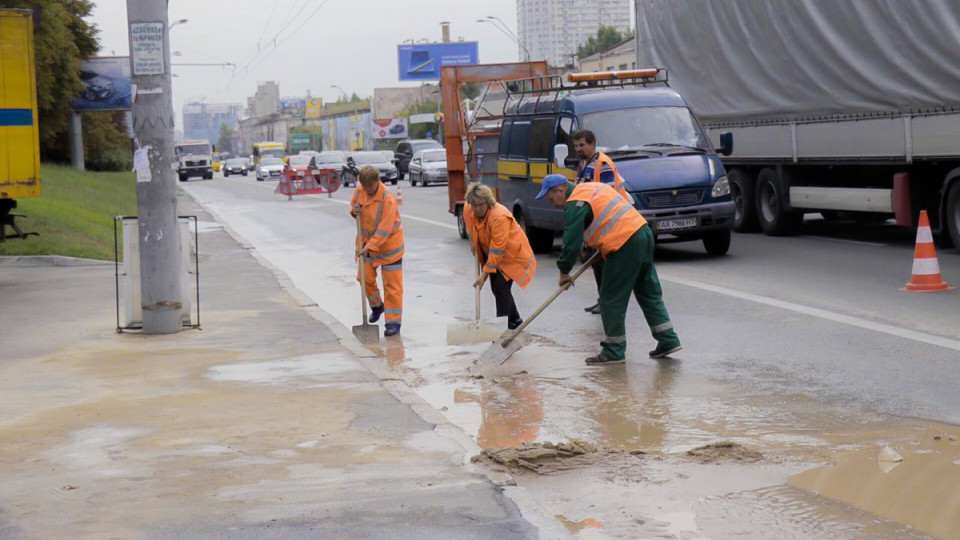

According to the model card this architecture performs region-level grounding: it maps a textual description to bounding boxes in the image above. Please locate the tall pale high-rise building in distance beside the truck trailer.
[517,0,631,67]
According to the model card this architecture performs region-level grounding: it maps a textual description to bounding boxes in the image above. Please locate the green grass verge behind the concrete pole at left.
[0,163,137,260]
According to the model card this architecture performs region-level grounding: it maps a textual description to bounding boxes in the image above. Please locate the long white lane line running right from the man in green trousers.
[660,275,960,351]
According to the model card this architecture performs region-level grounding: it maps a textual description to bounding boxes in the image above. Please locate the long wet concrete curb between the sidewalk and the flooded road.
[178,186,575,539]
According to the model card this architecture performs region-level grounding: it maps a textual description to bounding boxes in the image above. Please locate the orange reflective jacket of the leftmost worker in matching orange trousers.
[350,182,403,267]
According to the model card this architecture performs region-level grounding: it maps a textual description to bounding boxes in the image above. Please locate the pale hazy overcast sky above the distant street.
[89,0,518,119]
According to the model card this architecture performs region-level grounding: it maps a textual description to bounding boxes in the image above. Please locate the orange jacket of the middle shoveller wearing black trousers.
[463,203,537,288]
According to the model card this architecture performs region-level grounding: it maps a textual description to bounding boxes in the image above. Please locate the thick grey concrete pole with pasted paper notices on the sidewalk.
[127,0,182,334]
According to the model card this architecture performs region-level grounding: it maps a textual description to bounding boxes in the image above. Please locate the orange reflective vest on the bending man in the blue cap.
[567,182,647,257]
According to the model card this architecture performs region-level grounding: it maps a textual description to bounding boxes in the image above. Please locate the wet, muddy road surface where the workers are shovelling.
[185,175,960,539]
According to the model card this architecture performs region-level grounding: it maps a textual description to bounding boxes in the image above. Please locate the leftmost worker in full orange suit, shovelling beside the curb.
[350,165,403,336]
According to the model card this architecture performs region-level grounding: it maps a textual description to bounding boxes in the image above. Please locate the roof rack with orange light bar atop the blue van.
[503,68,670,116]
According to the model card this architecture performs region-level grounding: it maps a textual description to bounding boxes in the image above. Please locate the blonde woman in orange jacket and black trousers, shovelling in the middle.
[463,184,537,330]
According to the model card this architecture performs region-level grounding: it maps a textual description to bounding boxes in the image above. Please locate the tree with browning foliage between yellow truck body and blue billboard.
[3,0,101,160]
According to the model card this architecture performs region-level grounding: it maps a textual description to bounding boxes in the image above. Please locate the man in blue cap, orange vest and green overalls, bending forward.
[537,174,681,365]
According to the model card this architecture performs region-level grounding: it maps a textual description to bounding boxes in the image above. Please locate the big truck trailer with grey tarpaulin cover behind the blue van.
[636,0,960,247]
